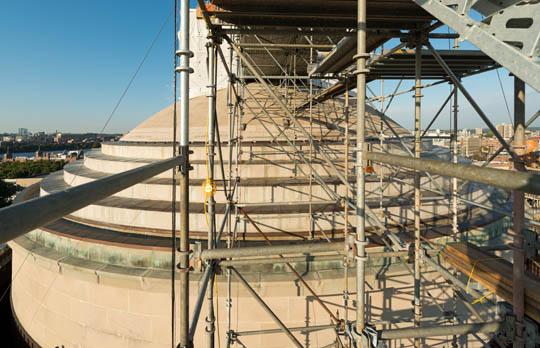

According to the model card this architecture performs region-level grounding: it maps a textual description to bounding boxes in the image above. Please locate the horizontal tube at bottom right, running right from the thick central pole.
[381,321,503,340]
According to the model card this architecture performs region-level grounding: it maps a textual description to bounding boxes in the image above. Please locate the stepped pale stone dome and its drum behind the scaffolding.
[6,84,506,348]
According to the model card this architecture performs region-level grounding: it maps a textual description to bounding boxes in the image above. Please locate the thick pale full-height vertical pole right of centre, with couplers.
[355,0,368,347]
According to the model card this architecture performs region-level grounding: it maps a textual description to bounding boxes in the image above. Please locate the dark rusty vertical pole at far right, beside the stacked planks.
[512,77,526,348]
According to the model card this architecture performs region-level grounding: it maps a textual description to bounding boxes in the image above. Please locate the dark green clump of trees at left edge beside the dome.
[0,160,65,179]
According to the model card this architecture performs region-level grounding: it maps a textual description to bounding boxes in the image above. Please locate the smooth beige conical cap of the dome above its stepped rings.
[121,83,410,142]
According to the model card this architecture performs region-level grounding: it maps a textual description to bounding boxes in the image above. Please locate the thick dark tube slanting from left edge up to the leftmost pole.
[0,156,181,243]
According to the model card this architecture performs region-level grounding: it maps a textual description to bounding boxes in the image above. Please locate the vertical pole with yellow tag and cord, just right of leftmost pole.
[204,41,217,348]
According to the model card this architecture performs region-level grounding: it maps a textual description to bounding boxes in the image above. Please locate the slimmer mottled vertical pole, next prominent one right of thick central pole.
[414,32,422,348]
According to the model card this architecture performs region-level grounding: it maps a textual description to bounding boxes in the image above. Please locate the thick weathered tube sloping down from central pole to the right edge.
[367,152,540,194]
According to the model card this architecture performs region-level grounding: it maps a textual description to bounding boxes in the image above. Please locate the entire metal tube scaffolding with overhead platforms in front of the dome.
[0,0,540,348]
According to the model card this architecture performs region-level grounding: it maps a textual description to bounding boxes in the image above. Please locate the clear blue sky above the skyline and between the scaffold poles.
[0,0,540,133]
